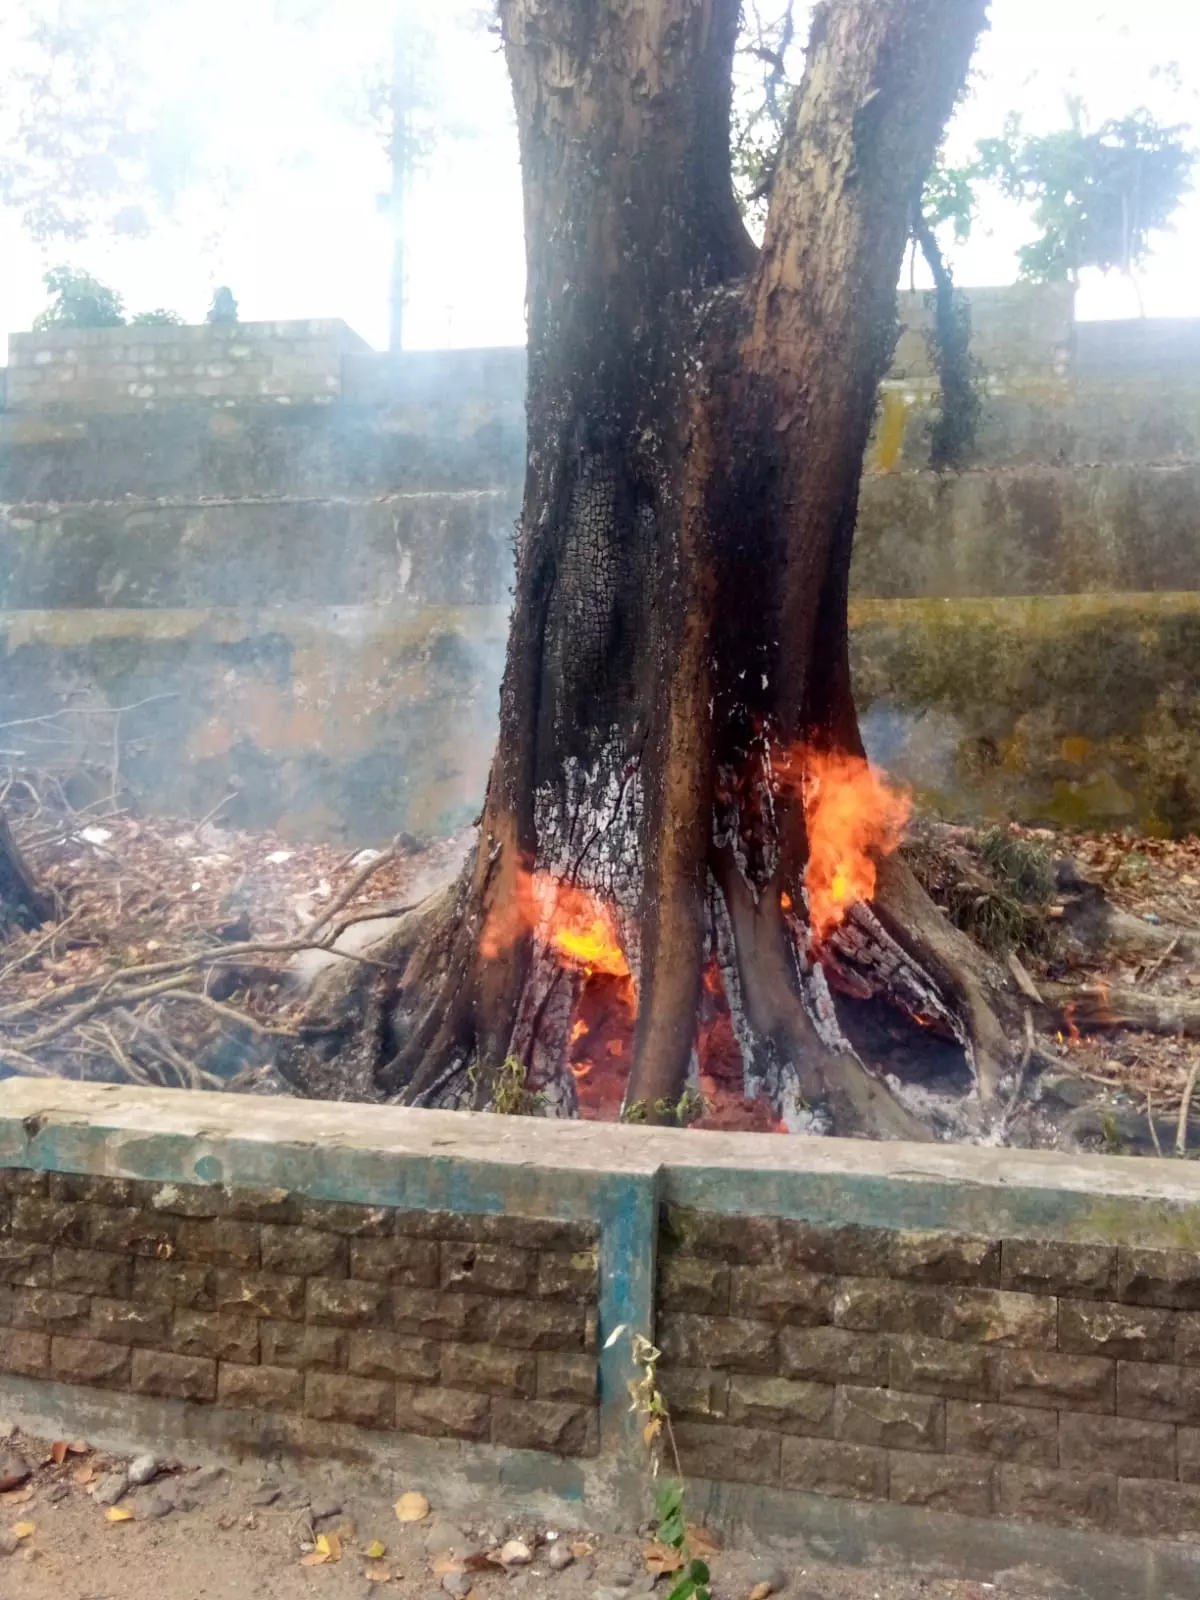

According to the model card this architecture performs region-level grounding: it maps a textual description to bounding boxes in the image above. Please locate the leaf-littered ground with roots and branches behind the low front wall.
[0,793,1200,1155]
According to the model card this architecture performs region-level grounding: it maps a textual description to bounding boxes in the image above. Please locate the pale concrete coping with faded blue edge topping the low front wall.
[11,1078,1200,1254]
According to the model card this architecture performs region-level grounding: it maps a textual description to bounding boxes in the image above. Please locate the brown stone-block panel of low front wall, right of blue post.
[658,1210,1200,1538]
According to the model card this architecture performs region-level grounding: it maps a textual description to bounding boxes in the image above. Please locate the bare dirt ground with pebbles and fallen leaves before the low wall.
[0,1422,1048,1600]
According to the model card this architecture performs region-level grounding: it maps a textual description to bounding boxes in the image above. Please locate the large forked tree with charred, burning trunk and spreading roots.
[299,0,1011,1136]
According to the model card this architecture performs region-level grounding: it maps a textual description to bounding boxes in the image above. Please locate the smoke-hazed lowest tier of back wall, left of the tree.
[0,605,507,842]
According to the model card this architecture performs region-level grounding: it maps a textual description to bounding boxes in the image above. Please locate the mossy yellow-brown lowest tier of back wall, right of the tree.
[851,594,1200,834]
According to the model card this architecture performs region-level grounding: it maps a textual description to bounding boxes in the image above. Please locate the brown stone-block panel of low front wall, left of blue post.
[0,1168,598,1456]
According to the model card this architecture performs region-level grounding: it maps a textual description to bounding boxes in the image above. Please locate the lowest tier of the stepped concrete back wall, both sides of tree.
[0,588,1200,842]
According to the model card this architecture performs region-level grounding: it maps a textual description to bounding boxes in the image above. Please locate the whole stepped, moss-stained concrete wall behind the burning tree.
[0,300,1200,837]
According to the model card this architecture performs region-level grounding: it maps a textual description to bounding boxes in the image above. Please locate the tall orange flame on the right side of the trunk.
[782,747,912,944]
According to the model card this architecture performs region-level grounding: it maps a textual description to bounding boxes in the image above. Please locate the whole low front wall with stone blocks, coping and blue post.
[0,1080,1200,1600]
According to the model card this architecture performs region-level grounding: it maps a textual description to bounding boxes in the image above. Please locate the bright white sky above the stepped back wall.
[0,0,1200,347]
